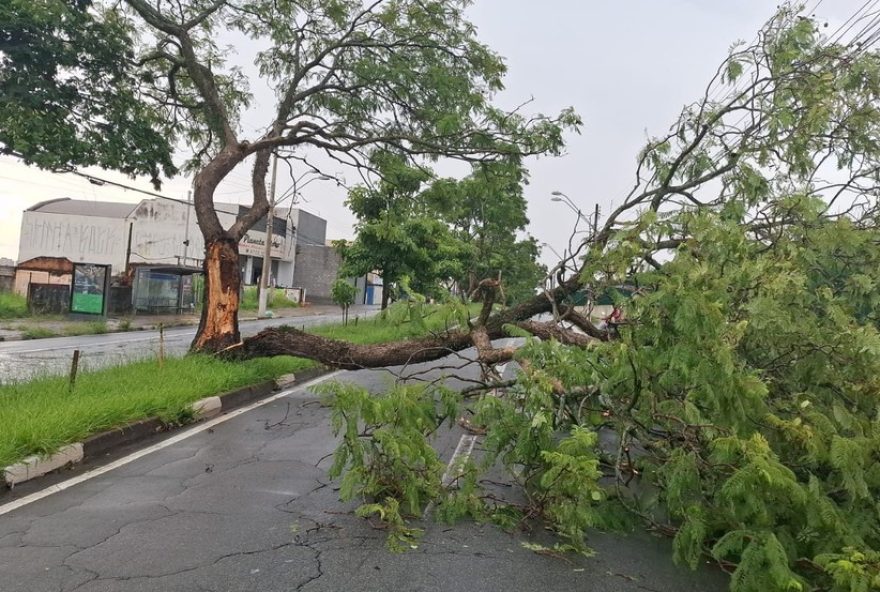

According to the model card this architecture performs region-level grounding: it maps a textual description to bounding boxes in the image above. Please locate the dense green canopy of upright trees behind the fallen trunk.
[342,153,544,302]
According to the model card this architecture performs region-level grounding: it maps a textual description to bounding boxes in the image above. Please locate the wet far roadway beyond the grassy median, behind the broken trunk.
[0,312,374,382]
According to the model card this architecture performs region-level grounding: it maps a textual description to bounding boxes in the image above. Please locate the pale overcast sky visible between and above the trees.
[0,0,862,262]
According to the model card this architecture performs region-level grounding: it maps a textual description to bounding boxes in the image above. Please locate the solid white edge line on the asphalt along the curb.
[0,370,343,516]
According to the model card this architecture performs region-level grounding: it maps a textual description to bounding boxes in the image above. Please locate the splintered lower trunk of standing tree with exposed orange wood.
[191,236,241,352]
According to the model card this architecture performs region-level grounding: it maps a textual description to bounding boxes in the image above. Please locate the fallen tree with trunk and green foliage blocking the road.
[244,6,880,592]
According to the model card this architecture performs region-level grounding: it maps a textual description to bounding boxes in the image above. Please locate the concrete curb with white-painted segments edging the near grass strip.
[0,367,332,489]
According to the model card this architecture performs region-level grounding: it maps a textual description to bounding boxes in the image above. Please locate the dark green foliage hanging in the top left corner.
[0,0,176,185]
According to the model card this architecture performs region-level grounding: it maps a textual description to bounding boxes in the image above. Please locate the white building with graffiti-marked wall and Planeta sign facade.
[18,198,327,287]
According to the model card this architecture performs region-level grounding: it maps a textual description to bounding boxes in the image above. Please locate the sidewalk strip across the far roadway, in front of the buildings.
[0,304,378,341]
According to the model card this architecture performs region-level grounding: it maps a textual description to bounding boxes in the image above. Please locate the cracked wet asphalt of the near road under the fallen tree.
[0,352,727,592]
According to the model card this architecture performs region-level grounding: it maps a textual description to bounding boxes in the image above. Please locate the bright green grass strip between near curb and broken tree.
[0,356,314,467]
